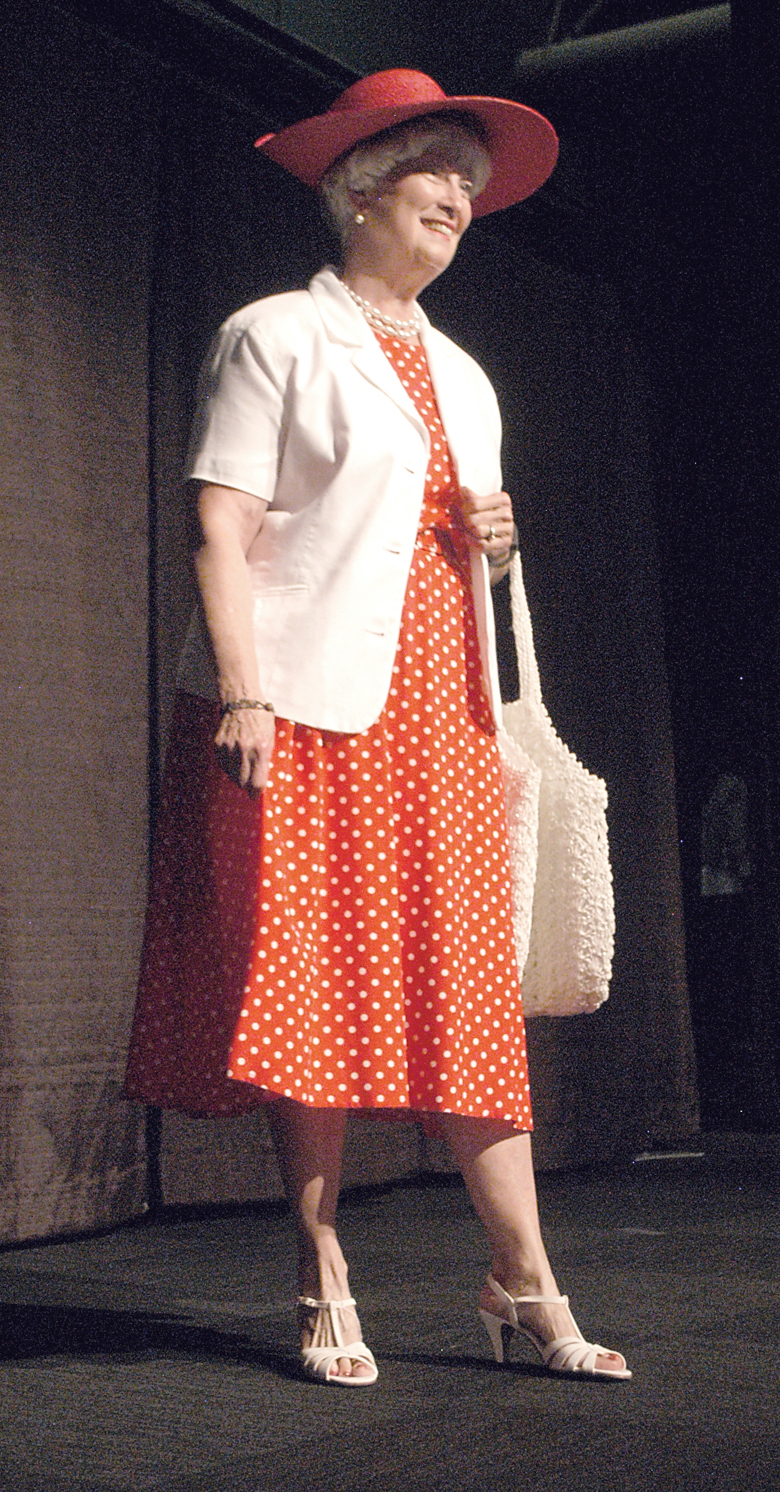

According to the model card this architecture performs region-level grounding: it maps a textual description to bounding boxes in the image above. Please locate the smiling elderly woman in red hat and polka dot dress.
[128,70,629,1386]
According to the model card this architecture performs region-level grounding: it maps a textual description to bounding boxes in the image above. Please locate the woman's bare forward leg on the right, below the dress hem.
[440,1115,625,1371]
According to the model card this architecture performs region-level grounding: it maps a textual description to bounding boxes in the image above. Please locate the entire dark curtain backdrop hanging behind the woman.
[0,6,695,1238]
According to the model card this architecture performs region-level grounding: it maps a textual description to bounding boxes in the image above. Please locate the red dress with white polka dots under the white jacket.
[128,336,532,1129]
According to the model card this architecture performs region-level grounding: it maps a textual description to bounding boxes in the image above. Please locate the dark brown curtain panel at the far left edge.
[0,4,154,1240]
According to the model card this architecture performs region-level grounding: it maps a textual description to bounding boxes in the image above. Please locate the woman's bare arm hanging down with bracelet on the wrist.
[192,482,274,794]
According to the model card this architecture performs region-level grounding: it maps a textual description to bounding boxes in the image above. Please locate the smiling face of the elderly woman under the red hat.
[353,157,471,294]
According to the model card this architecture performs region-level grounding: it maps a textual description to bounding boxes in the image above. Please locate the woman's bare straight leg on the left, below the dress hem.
[267,1098,370,1377]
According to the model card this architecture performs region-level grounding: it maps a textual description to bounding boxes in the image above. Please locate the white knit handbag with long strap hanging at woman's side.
[498,555,614,1016]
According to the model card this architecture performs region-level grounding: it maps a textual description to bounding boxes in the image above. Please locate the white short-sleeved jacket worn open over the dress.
[179,269,501,734]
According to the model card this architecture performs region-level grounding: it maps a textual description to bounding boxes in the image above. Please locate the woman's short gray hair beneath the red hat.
[319,110,491,245]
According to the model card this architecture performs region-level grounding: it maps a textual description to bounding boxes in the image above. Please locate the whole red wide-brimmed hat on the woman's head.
[255,67,558,218]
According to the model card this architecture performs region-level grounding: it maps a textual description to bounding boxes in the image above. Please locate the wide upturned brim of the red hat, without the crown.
[255,97,558,218]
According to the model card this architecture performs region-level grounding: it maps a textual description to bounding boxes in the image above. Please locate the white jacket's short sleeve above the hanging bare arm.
[186,322,283,503]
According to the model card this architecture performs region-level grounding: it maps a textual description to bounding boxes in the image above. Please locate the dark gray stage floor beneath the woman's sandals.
[0,1137,780,1492]
